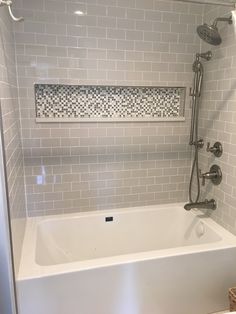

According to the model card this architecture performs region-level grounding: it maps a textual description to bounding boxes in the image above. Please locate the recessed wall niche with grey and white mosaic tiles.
[35,84,185,121]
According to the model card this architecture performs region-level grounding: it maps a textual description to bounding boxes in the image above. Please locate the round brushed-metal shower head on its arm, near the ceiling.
[197,16,233,46]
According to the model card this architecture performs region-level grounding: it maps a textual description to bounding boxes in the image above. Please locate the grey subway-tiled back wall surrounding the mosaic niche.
[15,0,203,216]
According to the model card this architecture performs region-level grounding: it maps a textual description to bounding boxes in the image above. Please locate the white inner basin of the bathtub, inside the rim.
[35,206,222,266]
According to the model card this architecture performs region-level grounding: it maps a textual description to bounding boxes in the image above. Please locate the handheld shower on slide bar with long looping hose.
[189,51,212,203]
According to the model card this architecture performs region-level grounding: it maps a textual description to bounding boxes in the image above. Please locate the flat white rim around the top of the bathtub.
[16,203,236,281]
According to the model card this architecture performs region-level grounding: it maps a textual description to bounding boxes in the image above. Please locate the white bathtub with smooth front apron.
[17,204,236,314]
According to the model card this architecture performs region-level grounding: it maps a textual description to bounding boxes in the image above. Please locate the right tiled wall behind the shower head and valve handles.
[200,6,236,234]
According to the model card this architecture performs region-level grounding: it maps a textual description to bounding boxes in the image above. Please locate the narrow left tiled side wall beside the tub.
[0,8,26,272]
